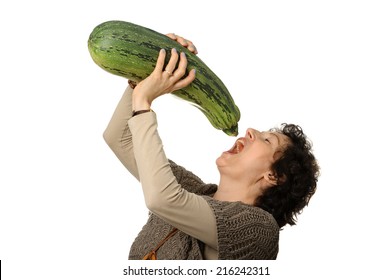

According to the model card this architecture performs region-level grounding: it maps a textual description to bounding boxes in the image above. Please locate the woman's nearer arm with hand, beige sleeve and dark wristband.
[128,47,217,248]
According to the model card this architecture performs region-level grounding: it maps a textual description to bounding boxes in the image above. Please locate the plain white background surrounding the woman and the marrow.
[0,0,391,279]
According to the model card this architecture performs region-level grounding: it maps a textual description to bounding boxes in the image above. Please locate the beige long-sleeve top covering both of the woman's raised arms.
[104,87,218,259]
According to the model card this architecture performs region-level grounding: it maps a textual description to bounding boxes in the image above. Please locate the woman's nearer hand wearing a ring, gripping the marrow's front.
[132,49,195,111]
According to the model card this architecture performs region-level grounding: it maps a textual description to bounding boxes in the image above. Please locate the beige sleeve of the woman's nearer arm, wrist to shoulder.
[128,112,217,249]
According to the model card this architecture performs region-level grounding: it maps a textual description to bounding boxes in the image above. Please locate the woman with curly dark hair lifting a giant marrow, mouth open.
[104,34,318,260]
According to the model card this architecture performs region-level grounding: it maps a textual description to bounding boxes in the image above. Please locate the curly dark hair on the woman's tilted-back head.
[255,123,320,228]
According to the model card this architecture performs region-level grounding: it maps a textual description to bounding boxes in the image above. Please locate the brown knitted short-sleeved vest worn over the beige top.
[129,161,280,260]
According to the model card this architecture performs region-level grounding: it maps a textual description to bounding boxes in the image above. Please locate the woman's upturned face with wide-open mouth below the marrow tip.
[216,128,290,182]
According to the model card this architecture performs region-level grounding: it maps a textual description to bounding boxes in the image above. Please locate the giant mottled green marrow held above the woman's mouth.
[88,21,240,136]
